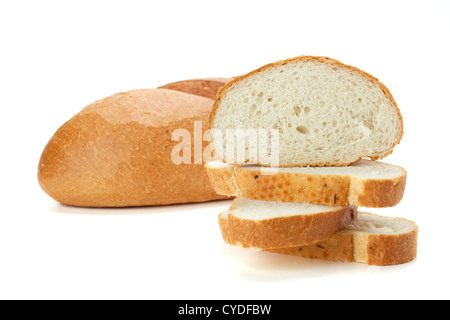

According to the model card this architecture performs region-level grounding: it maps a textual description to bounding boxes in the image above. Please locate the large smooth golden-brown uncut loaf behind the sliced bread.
[38,79,232,207]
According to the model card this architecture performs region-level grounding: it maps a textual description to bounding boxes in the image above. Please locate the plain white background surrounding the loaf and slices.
[0,0,450,299]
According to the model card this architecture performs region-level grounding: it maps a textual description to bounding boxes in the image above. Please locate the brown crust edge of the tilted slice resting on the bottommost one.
[219,202,357,249]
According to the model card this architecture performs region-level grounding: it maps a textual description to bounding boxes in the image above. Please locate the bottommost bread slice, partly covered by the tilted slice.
[270,212,419,266]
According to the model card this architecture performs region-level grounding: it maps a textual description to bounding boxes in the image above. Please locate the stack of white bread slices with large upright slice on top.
[206,56,418,266]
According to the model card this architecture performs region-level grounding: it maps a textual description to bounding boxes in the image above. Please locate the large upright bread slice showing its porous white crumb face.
[210,56,403,167]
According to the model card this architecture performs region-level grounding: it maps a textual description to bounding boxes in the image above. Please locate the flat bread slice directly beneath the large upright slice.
[205,160,406,208]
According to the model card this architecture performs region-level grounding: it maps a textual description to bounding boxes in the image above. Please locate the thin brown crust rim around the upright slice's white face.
[209,55,404,168]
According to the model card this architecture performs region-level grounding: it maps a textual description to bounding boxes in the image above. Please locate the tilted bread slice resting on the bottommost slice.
[219,198,357,249]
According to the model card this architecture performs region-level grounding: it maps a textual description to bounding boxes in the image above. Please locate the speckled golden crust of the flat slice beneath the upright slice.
[206,165,407,208]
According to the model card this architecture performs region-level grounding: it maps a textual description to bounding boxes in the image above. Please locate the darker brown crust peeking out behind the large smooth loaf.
[158,78,232,99]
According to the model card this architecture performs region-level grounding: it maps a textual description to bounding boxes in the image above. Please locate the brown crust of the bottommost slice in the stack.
[267,213,419,266]
